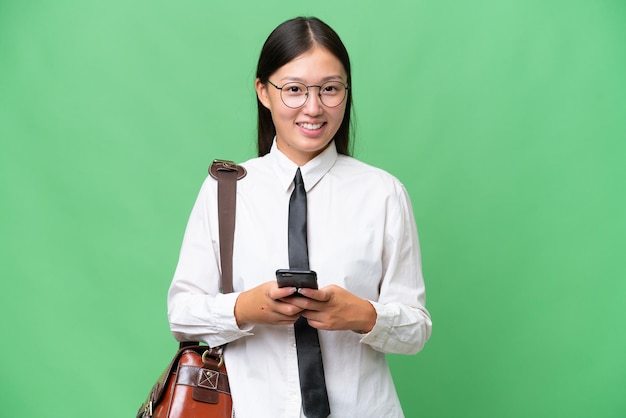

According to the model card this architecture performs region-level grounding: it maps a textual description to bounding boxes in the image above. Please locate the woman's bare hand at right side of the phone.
[288,285,377,334]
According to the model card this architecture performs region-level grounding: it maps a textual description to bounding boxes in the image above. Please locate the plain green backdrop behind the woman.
[0,0,626,418]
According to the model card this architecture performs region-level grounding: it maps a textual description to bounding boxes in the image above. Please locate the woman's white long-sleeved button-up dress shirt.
[168,143,431,418]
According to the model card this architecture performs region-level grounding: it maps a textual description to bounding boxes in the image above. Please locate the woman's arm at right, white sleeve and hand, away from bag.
[290,184,432,354]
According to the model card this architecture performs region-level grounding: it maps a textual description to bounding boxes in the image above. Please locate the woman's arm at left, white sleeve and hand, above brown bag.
[168,179,302,346]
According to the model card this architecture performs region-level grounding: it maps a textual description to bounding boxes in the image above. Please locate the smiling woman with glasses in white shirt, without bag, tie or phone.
[168,18,431,418]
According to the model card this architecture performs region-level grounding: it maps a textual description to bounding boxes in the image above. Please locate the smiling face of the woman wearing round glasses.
[255,46,348,166]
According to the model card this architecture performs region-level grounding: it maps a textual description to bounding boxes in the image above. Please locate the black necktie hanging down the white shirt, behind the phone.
[289,168,330,418]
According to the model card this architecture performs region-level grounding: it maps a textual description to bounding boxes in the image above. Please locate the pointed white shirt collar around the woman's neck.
[269,138,338,192]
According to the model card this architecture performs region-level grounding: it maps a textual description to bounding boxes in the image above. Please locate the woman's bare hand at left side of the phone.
[235,281,302,327]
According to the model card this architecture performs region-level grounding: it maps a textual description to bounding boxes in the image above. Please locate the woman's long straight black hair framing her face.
[256,17,352,156]
